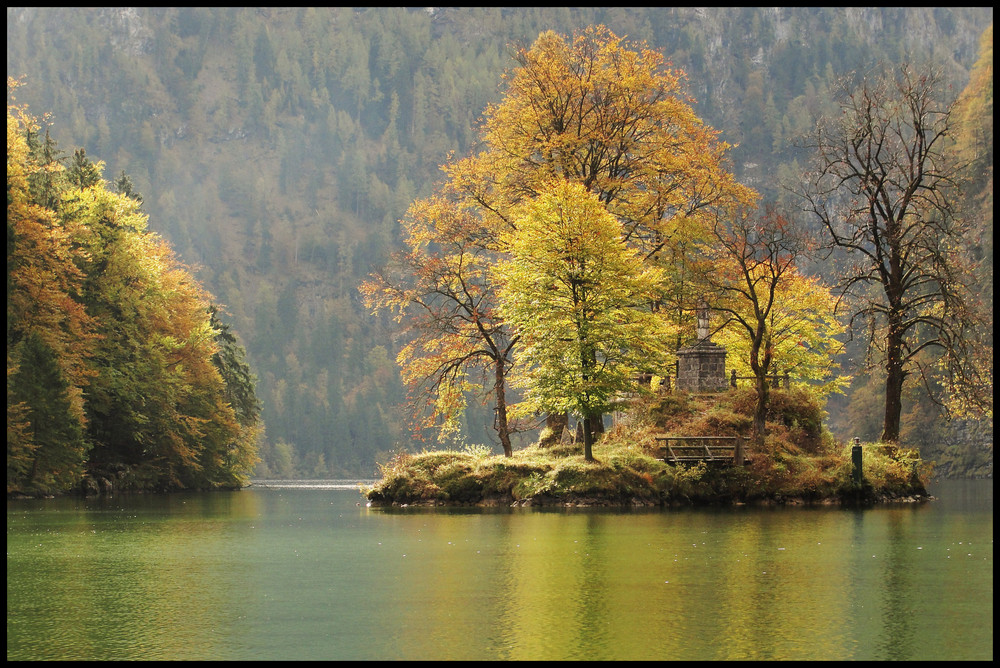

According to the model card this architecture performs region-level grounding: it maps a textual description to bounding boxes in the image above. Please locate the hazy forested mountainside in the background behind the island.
[7,7,993,476]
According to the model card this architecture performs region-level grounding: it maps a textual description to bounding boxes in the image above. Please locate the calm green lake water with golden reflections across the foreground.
[7,480,993,660]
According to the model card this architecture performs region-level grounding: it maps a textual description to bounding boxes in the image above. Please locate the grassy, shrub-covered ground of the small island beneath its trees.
[363,388,930,507]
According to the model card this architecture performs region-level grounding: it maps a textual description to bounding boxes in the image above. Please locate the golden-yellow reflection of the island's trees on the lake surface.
[390,511,860,661]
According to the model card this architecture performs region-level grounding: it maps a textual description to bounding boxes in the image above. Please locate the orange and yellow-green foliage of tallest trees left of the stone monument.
[362,26,756,450]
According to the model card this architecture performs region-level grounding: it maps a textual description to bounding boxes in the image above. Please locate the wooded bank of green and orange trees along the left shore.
[7,88,260,493]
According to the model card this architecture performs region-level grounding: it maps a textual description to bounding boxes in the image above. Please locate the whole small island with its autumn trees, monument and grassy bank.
[359,26,976,506]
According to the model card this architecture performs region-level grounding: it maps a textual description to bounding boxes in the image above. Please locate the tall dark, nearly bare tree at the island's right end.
[801,64,987,442]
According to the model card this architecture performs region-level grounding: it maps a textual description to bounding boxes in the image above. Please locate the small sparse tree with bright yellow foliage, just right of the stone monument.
[701,205,846,447]
